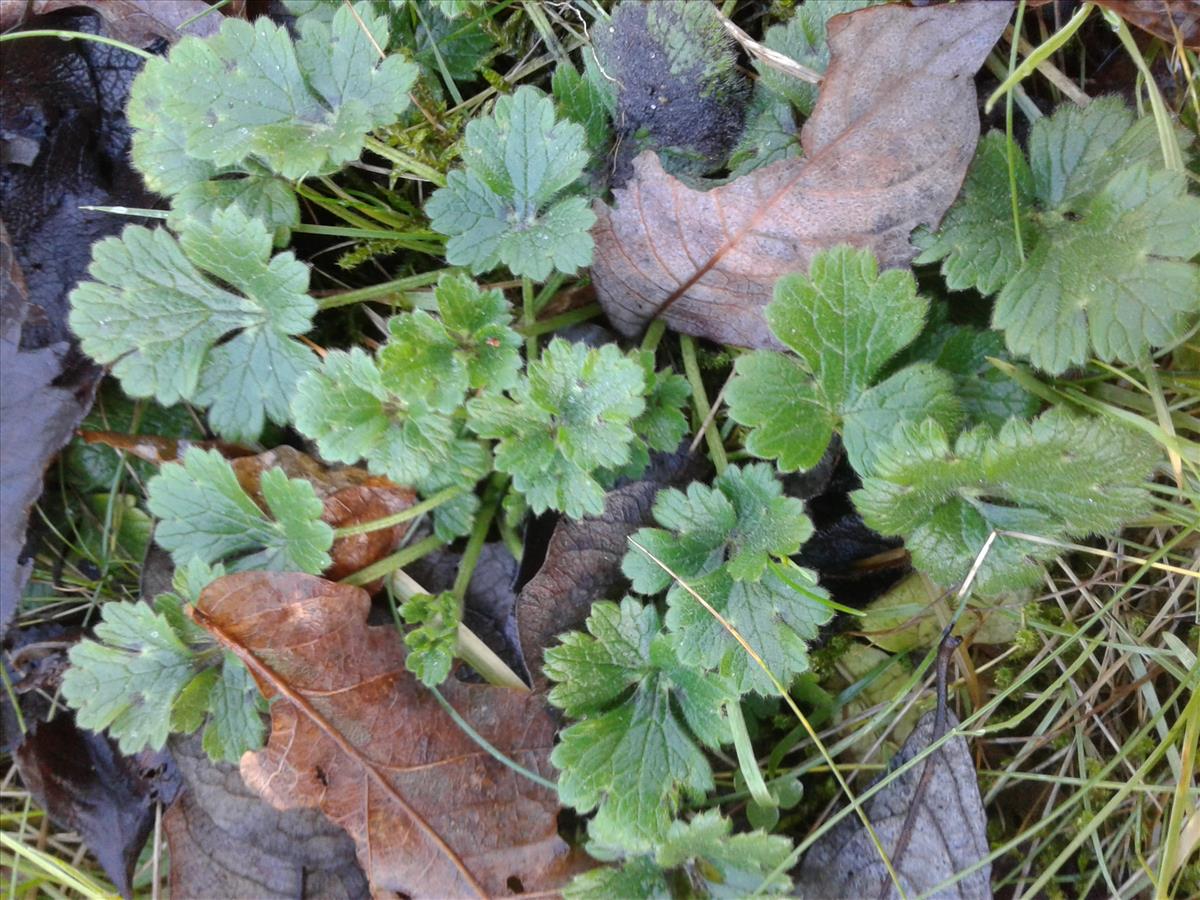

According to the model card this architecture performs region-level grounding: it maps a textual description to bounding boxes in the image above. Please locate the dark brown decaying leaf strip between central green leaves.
[517,452,692,689]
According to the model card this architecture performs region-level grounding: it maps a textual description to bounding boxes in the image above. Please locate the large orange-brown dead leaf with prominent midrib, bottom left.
[193,572,571,896]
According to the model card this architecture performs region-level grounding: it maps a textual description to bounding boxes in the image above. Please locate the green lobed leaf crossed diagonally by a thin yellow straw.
[622,463,833,695]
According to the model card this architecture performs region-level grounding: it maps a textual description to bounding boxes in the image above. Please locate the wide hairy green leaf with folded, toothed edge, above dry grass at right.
[853,409,1156,596]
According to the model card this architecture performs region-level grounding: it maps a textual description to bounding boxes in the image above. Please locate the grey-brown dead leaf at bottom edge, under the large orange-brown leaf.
[163,734,370,900]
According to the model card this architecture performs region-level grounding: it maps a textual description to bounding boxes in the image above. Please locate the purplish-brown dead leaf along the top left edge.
[0,0,221,47]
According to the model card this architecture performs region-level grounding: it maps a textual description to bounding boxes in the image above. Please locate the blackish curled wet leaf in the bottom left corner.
[14,710,179,896]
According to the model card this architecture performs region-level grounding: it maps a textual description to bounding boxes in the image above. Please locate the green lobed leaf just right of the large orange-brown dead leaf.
[545,598,733,852]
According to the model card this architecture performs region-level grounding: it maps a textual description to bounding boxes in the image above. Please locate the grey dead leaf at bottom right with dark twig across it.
[798,712,991,900]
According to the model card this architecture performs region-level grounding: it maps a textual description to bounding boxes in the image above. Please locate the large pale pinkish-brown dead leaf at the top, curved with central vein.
[592,0,1013,347]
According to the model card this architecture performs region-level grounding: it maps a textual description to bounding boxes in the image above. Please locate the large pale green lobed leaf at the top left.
[131,2,416,183]
